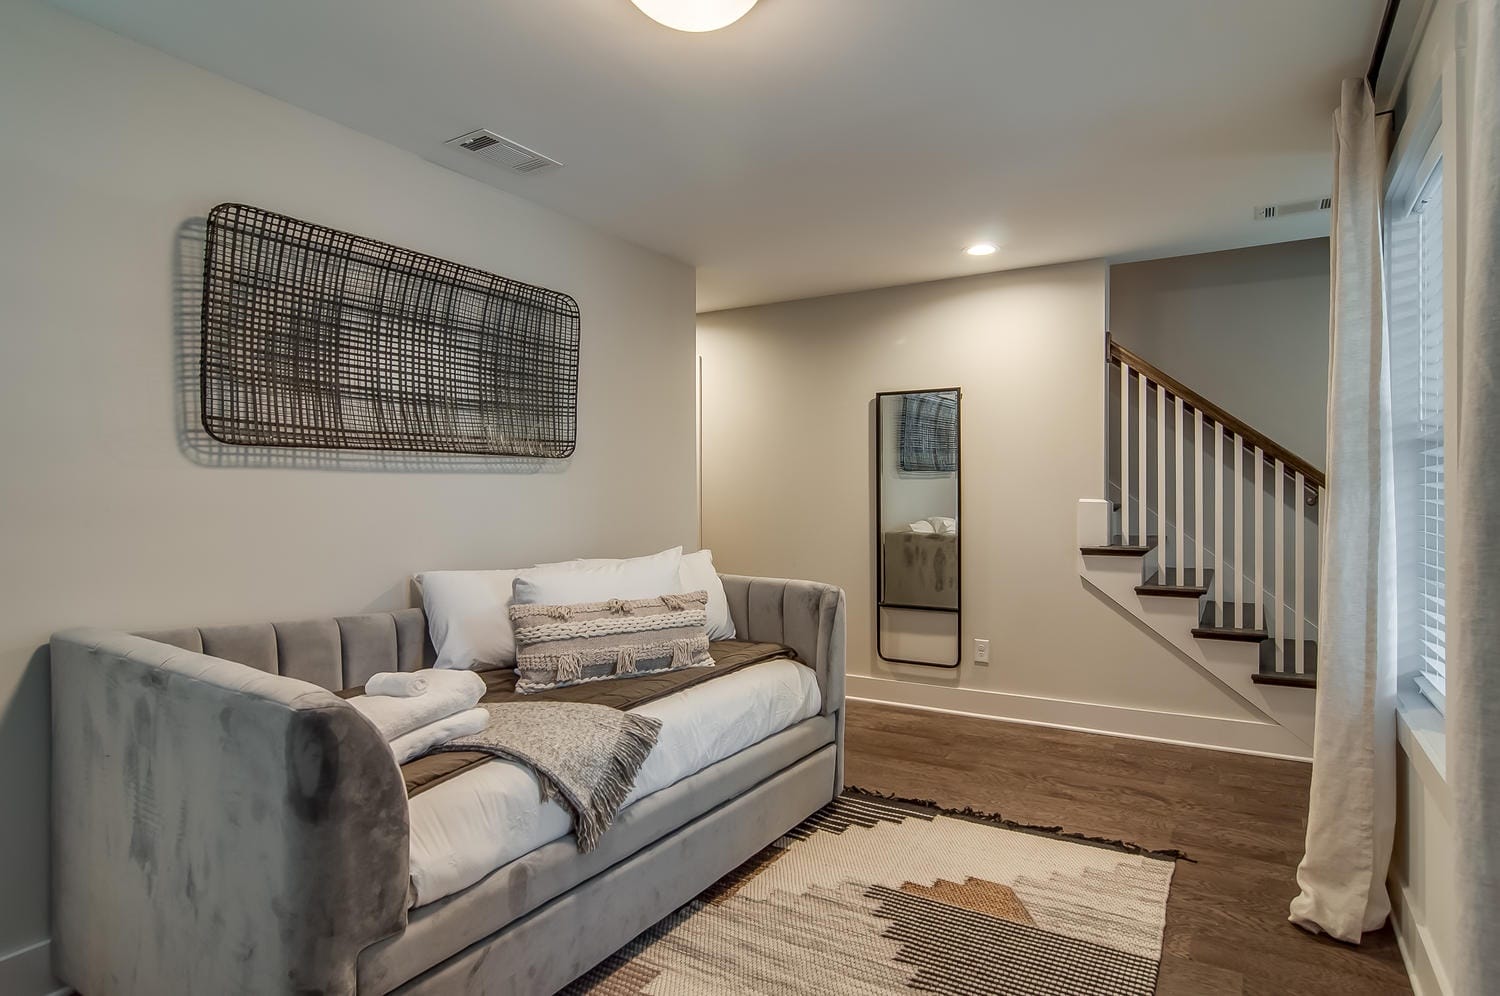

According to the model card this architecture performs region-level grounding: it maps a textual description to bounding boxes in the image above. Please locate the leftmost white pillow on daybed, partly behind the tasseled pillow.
[417,570,522,669]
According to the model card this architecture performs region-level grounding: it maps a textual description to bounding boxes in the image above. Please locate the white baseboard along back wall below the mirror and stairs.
[846,675,1311,761]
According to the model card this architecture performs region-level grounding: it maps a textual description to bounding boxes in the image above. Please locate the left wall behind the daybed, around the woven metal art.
[0,0,698,993]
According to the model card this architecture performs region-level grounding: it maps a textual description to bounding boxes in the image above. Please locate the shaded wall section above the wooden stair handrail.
[1110,239,1329,467]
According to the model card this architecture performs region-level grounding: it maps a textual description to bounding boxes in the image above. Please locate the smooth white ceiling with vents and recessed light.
[54,0,1382,311]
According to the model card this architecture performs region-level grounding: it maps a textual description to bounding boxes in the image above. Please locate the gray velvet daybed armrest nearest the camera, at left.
[51,630,410,993]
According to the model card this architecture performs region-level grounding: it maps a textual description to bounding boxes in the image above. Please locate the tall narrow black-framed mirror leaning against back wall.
[875,387,962,668]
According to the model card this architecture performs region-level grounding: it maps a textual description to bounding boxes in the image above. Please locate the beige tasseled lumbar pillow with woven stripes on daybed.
[510,591,714,692]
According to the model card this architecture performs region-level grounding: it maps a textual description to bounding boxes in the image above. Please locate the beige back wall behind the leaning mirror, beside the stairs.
[699,263,1272,750]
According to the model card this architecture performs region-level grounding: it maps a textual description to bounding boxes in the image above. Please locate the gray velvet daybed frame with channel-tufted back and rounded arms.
[51,576,845,996]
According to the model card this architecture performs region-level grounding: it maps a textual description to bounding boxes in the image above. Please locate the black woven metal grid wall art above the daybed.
[200,204,579,459]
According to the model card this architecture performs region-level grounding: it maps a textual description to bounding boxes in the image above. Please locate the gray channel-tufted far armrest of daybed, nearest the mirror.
[719,575,845,716]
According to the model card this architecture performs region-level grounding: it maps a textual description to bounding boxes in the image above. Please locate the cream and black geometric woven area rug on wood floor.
[567,792,1176,996]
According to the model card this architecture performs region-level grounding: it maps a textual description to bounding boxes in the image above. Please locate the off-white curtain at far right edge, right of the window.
[1446,0,1500,993]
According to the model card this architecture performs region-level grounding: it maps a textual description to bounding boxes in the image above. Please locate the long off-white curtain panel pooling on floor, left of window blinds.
[1292,80,1397,944]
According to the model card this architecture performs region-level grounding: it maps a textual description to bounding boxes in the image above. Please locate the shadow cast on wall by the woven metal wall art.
[173,218,572,474]
